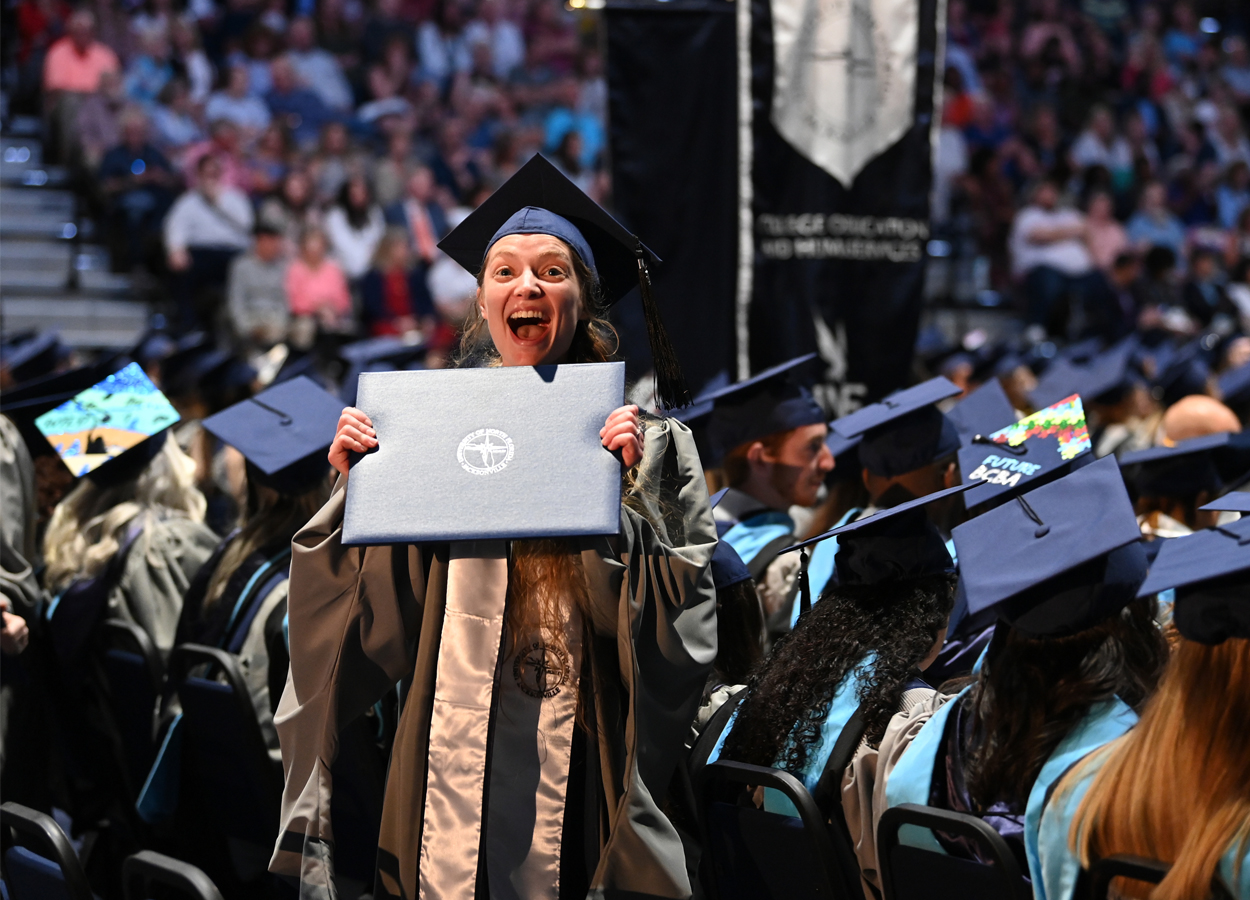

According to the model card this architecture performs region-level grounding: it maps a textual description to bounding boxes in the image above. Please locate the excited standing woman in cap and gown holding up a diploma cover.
[270,158,716,900]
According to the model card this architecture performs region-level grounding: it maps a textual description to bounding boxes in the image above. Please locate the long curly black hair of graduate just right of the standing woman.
[724,575,955,771]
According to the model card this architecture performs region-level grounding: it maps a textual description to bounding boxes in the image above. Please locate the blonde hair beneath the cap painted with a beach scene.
[44,435,206,591]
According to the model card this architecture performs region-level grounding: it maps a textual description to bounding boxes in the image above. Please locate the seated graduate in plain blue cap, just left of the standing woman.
[178,376,340,759]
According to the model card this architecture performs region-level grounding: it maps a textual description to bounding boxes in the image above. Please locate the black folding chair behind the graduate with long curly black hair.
[698,760,863,900]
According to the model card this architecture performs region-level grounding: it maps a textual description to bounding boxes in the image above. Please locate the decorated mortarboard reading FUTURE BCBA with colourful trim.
[959,395,1093,509]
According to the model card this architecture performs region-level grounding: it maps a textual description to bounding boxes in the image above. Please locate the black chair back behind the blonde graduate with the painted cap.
[100,619,165,793]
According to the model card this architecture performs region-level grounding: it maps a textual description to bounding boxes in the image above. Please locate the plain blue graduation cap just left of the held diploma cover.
[204,376,343,495]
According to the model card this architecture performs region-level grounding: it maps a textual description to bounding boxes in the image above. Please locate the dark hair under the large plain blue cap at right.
[964,599,1168,810]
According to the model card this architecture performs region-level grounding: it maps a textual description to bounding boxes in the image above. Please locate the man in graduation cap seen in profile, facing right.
[696,354,834,635]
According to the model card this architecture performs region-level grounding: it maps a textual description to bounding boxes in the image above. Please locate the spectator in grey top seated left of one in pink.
[226,219,290,358]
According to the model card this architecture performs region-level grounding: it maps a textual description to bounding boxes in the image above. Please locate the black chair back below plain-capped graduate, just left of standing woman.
[169,644,283,846]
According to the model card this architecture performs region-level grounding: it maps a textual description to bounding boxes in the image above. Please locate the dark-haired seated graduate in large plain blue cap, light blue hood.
[846,459,1168,884]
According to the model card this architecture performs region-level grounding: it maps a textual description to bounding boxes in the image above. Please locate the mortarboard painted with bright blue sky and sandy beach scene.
[34,363,179,485]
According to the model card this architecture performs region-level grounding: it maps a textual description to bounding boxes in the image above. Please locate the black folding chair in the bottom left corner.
[0,803,94,900]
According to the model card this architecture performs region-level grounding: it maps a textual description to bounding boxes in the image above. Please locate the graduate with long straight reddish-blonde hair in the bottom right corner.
[1040,518,1250,900]
